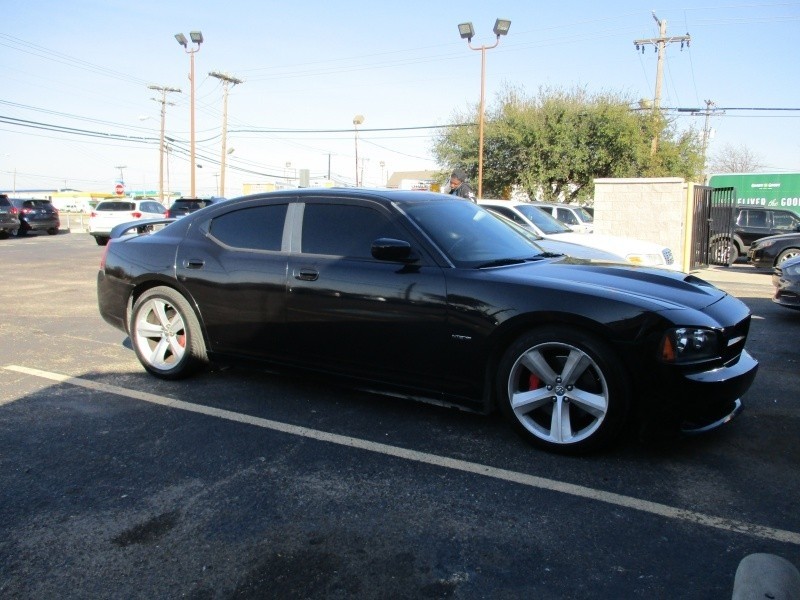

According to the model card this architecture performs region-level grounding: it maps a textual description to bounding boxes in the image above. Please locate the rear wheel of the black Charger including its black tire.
[129,287,208,379]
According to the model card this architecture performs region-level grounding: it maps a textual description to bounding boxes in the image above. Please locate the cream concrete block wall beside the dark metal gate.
[594,177,689,265]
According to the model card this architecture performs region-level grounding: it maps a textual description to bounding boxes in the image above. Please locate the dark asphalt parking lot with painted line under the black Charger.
[0,233,800,599]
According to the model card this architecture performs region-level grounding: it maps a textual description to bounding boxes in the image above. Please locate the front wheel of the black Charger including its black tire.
[496,326,630,454]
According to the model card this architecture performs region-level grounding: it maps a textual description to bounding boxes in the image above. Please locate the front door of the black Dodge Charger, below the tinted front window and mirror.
[287,198,448,389]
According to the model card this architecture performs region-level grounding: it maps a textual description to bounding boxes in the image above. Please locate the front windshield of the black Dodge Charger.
[400,200,544,268]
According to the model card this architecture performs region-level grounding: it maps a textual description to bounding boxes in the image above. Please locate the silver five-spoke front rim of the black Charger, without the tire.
[508,342,609,445]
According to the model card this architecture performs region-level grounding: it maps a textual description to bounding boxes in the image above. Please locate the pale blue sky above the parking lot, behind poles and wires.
[0,0,800,196]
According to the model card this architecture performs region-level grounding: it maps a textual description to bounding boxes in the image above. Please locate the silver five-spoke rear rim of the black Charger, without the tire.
[132,297,191,371]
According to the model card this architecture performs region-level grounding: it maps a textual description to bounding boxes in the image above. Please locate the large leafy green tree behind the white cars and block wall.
[433,88,703,202]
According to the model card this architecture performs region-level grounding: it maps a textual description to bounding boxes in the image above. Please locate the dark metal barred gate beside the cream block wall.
[690,185,737,269]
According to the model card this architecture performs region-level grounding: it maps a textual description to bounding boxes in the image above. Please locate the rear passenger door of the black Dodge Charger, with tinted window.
[176,201,288,358]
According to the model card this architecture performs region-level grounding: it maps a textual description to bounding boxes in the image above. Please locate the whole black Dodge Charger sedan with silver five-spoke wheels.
[97,189,758,453]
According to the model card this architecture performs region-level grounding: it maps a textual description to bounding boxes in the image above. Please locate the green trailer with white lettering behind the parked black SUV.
[708,173,800,215]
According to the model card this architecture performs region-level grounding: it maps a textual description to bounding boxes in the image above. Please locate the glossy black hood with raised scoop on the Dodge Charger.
[495,259,727,310]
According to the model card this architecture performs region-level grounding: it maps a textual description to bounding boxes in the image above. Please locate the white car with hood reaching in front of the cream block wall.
[478,200,680,271]
